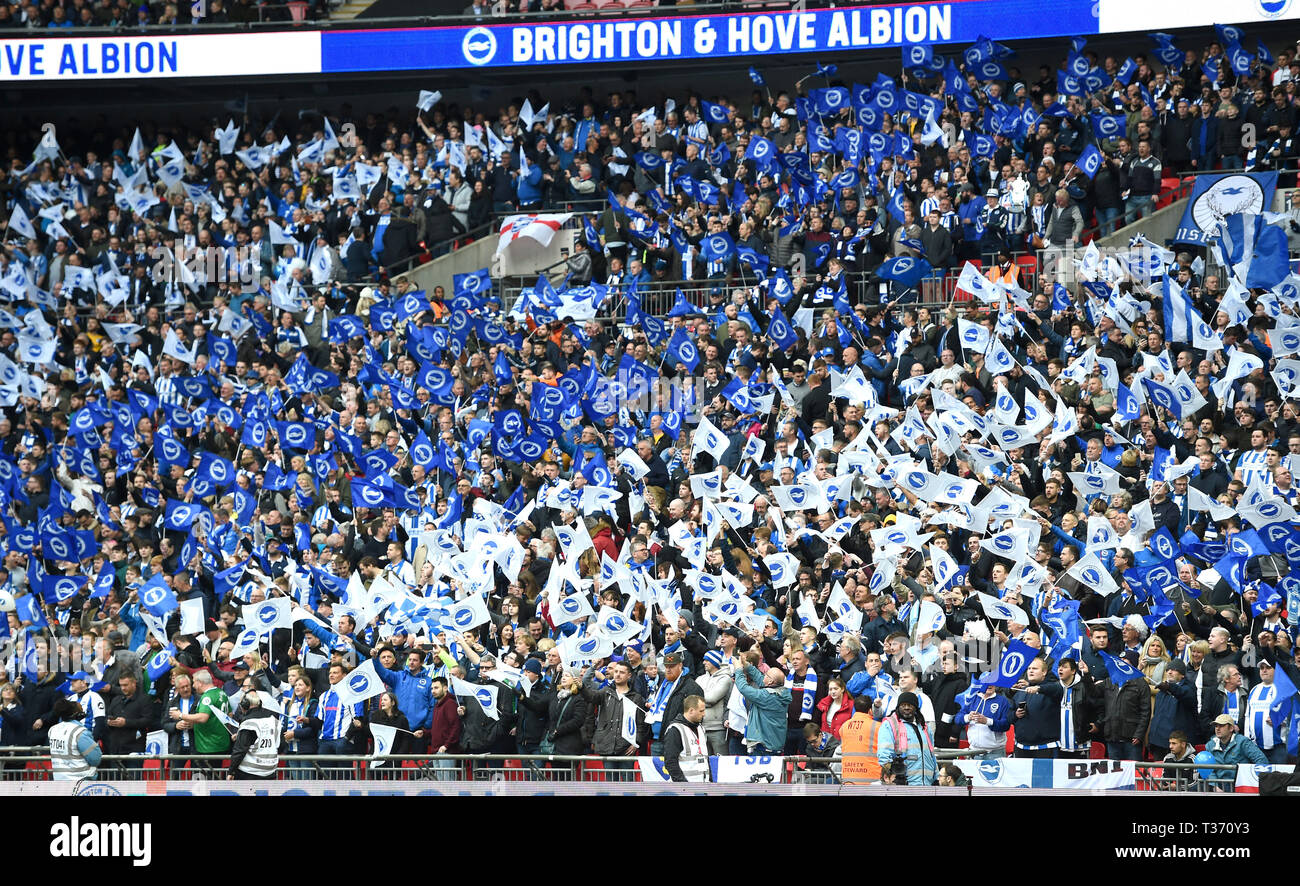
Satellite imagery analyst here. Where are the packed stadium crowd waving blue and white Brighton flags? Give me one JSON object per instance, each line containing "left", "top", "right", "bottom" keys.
{"left": 0, "top": 29, "right": 1300, "bottom": 783}
